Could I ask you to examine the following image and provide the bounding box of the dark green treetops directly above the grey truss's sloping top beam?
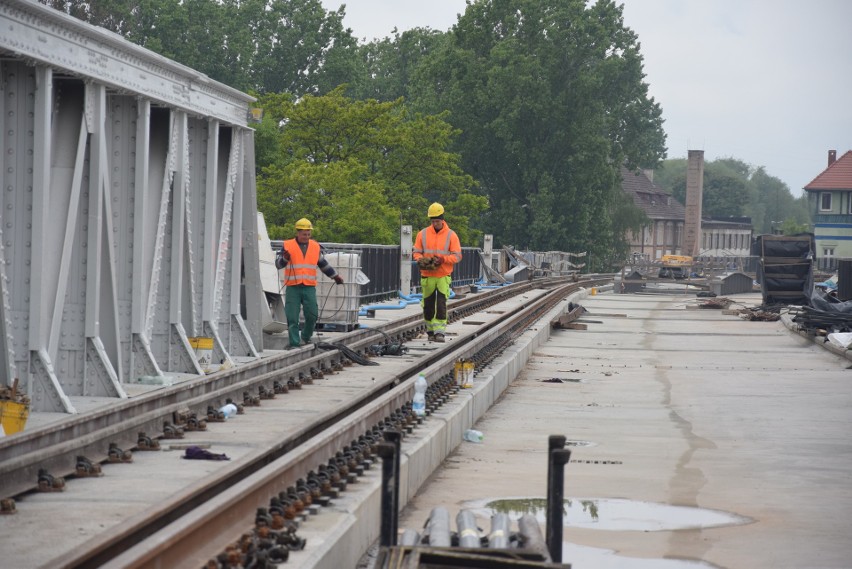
[42,0,366,95]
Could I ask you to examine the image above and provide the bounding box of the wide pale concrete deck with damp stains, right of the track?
[400,294,852,569]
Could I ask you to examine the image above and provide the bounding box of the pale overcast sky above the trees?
[322,0,852,196]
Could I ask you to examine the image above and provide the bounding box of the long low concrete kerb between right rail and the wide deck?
[290,287,588,569]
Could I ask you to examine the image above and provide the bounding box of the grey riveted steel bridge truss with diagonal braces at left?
[0,0,263,413]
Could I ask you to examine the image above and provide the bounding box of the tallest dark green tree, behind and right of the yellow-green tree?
[411,0,665,266]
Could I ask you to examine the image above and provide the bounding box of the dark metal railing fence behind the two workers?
[272,241,482,304]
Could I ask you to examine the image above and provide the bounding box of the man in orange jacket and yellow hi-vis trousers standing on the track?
[414,202,461,342]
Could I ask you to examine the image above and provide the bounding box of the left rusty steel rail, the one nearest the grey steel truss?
[0,278,596,498]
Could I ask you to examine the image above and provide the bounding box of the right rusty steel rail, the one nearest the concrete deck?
[71,280,605,568]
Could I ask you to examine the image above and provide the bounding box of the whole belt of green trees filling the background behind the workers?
[40,0,809,262]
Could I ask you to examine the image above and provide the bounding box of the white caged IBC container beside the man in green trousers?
[317,252,361,331]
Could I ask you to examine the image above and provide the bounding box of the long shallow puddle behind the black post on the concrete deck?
[463,497,751,531]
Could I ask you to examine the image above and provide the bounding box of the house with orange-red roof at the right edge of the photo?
[804,146,852,265]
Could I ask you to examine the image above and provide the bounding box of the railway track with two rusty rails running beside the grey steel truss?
[0,276,610,567]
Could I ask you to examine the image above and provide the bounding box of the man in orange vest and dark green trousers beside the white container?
[275,217,343,347]
